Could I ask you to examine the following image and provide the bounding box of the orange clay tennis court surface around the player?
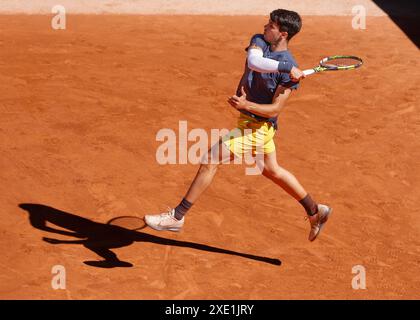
[0,15,420,299]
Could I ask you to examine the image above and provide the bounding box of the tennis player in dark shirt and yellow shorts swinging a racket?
[145,9,332,241]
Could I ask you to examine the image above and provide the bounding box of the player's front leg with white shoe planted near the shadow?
[145,139,234,231]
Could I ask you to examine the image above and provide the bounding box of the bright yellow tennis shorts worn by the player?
[222,113,276,157]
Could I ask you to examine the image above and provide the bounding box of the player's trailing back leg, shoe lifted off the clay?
[262,152,332,241]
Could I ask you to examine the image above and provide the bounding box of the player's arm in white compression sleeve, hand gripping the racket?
[247,44,305,81]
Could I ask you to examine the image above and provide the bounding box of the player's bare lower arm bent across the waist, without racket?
[228,86,292,118]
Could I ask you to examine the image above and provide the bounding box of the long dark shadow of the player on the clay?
[19,203,281,268]
